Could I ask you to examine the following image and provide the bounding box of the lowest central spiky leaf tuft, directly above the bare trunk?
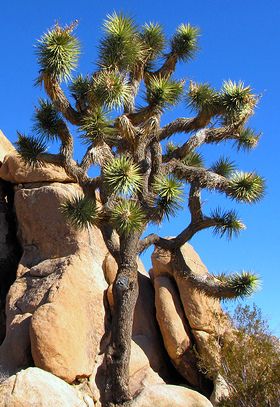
[111,199,145,234]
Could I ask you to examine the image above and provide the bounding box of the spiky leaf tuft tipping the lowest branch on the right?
[215,271,261,298]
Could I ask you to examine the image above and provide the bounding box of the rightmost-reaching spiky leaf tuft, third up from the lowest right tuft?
[228,171,265,203]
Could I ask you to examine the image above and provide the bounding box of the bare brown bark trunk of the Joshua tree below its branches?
[105,233,139,407]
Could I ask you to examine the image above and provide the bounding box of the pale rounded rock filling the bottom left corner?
[0,368,94,407]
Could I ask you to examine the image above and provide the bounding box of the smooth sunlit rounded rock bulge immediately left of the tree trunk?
[30,254,106,383]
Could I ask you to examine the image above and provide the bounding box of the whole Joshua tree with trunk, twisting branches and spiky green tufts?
[17,14,264,405]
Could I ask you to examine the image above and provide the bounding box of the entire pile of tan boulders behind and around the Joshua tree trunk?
[0,133,230,407]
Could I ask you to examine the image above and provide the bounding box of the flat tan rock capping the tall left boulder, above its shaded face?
[0,152,73,184]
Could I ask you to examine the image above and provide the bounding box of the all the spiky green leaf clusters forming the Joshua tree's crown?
[17,13,264,293]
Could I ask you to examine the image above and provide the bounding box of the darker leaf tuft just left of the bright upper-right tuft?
[187,82,220,115]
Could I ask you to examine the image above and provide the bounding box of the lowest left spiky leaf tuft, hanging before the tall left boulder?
[60,195,100,229]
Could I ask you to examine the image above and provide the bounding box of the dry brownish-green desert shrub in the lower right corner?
[200,305,280,407]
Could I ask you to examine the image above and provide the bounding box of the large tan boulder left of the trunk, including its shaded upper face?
[0,183,107,383]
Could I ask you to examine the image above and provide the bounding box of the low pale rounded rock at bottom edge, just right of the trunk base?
[131,384,212,407]
